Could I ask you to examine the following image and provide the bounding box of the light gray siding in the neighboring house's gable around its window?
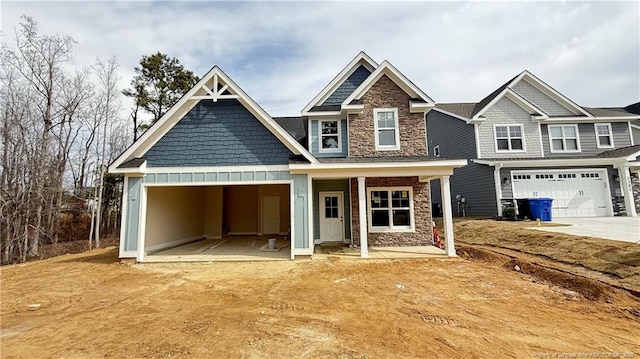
[477,98,542,158]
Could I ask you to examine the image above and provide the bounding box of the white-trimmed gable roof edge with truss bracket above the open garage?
[109,66,317,172]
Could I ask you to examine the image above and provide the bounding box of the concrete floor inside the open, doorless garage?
[144,236,291,263]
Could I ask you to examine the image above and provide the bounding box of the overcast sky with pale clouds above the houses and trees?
[0,1,640,116]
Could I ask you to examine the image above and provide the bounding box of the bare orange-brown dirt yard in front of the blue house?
[0,224,640,358]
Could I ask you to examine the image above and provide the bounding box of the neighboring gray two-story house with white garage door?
[426,71,640,217]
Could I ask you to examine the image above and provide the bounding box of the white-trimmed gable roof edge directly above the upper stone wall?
[342,60,435,106]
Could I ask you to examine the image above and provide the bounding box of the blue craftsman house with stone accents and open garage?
[109,53,467,262]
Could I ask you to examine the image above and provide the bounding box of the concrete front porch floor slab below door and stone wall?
[312,246,448,259]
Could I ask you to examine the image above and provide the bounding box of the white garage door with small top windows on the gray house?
[511,169,612,217]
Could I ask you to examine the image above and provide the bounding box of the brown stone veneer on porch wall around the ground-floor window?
[351,177,433,247]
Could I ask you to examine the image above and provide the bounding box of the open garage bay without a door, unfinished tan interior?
[144,184,291,262]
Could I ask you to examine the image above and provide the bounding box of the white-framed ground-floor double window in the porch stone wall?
[367,187,415,232]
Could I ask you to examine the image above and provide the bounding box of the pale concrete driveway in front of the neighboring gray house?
[529,217,640,244]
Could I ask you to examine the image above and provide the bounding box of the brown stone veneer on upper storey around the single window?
[349,75,427,157]
